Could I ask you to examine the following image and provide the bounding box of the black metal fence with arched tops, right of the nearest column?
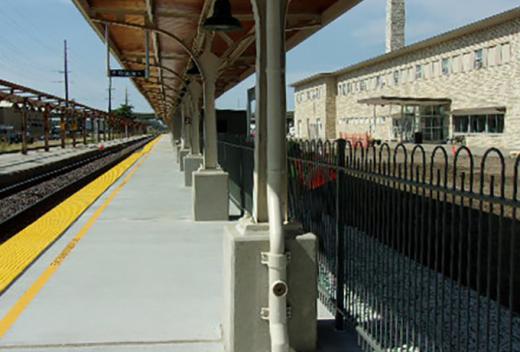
[217,135,520,351]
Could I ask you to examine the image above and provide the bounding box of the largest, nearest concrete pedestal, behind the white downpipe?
[222,220,317,352]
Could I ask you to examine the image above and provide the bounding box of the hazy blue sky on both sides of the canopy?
[0,0,520,111]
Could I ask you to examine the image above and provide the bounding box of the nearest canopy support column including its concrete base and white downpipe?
[222,0,318,352]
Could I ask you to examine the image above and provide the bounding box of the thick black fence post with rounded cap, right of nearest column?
[335,139,347,330]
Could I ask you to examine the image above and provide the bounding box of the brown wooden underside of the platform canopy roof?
[73,0,361,117]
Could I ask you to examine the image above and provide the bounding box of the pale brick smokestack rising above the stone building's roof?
[386,0,406,53]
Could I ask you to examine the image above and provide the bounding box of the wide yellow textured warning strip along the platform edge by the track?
[0,139,158,293]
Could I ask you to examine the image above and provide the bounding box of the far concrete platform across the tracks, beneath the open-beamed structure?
[0,136,142,176]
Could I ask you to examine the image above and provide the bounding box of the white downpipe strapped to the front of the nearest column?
[266,0,289,352]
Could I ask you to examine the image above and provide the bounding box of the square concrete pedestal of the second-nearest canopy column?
[193,170,229,221]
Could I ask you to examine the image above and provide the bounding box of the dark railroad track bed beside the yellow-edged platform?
[0,137,152,244]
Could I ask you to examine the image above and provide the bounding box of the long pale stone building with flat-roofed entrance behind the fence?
[293,5,520,147]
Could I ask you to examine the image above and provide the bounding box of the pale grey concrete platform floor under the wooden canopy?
[0,137,228,352]
